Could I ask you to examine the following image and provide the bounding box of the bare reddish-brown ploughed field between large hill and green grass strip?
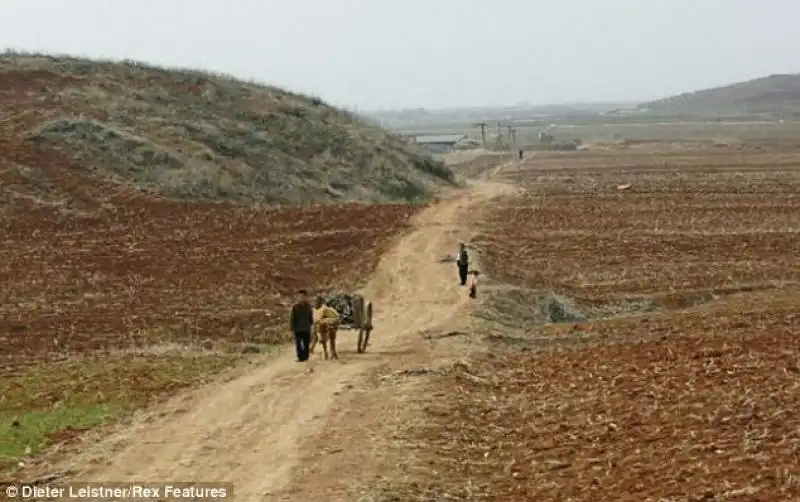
[0,192,417,370]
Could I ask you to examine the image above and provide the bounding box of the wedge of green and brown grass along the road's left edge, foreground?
[0,354,240,473]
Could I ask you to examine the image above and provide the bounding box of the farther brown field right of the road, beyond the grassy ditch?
[478,150,800,301]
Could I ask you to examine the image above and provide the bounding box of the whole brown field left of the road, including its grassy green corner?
[0,140,423,471]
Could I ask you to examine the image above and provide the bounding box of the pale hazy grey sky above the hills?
[0,0,800,110]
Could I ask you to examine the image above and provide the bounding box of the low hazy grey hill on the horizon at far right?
[638,75,800,116]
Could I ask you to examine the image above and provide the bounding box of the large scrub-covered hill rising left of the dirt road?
[0,53,454,204]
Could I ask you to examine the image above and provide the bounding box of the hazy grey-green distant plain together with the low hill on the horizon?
[383,70,800,144]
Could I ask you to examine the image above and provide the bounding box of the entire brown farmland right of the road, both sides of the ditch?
[379,145,800,502]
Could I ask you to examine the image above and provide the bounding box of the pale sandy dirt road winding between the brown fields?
[59,178,509,500]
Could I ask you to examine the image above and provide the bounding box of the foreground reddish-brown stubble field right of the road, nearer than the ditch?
[390,295,800,502]
